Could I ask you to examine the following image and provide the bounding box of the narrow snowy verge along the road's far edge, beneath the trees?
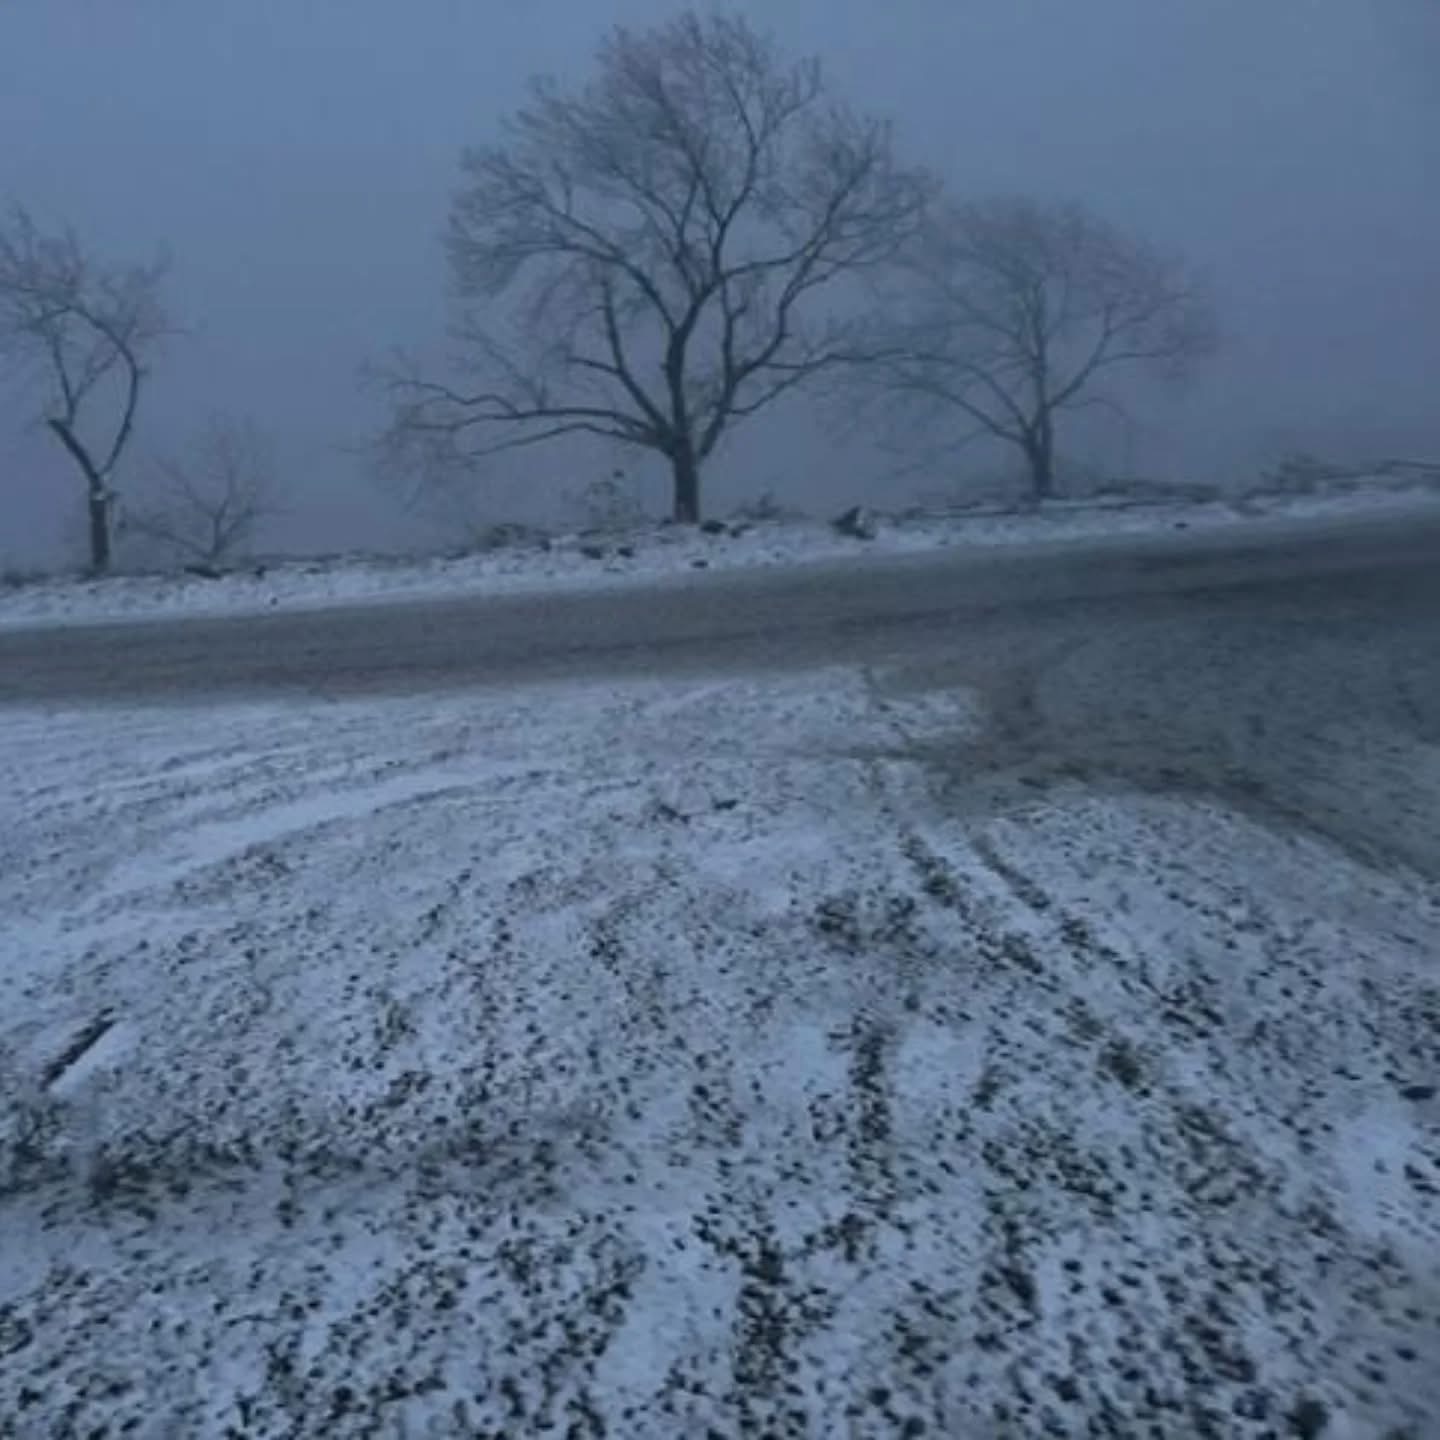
[0,480,1440,626]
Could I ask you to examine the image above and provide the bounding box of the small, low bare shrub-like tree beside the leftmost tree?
[124,416,278,570]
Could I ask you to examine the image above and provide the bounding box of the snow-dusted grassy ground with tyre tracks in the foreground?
[0,671,1440,1440]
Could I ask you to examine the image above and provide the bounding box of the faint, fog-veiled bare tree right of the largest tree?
[874,199,1215,500]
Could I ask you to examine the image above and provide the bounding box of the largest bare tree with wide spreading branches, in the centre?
[389,14,930,521]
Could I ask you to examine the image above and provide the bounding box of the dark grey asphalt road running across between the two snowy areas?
[0,509,1440,704]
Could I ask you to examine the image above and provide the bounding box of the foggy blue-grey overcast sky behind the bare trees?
[0,0,1440,564]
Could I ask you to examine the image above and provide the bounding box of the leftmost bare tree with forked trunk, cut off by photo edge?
[0,209,168,572]
